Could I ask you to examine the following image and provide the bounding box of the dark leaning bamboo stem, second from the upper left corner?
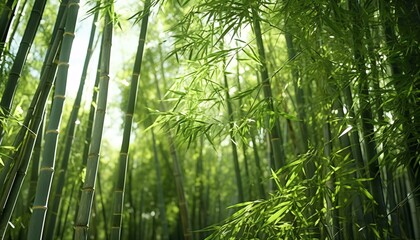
[0,0,46,144]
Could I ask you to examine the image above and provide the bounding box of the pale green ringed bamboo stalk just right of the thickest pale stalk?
[74,1,113,239]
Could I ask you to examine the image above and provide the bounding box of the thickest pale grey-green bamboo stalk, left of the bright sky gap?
[28,0,79,239]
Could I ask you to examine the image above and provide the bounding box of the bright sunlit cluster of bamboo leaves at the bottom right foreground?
[206,150,376,239]
